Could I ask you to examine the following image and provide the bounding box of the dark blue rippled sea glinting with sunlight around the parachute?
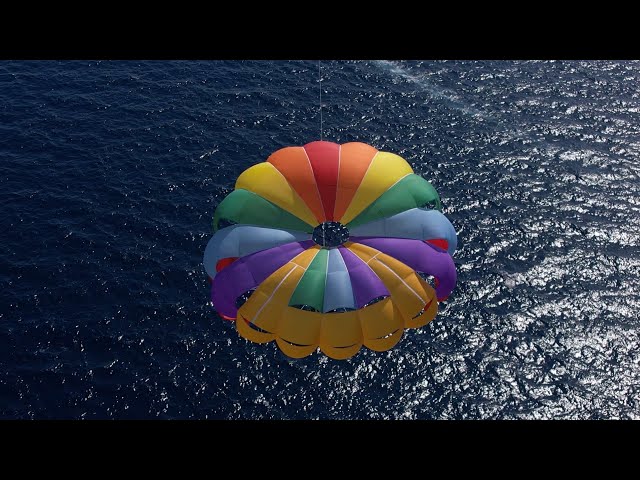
[0,61,640,419]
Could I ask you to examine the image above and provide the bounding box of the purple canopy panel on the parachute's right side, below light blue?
[351,237,457,301]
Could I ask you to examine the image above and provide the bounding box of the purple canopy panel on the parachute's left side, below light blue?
[211,240,313,318]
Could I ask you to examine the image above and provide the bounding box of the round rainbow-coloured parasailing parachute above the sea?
[204,141,457,359]
